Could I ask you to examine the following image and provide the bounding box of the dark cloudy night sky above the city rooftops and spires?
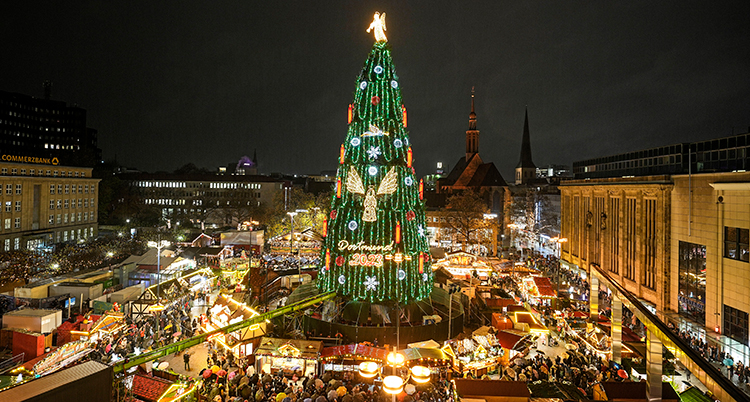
[0,0,750,180]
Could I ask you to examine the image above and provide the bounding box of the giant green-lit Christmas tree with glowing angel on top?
[318,13,433,303]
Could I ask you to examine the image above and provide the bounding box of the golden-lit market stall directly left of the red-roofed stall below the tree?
[255,337,323,376]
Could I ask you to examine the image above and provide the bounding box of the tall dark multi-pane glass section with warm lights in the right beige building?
[678,241,706,325]
